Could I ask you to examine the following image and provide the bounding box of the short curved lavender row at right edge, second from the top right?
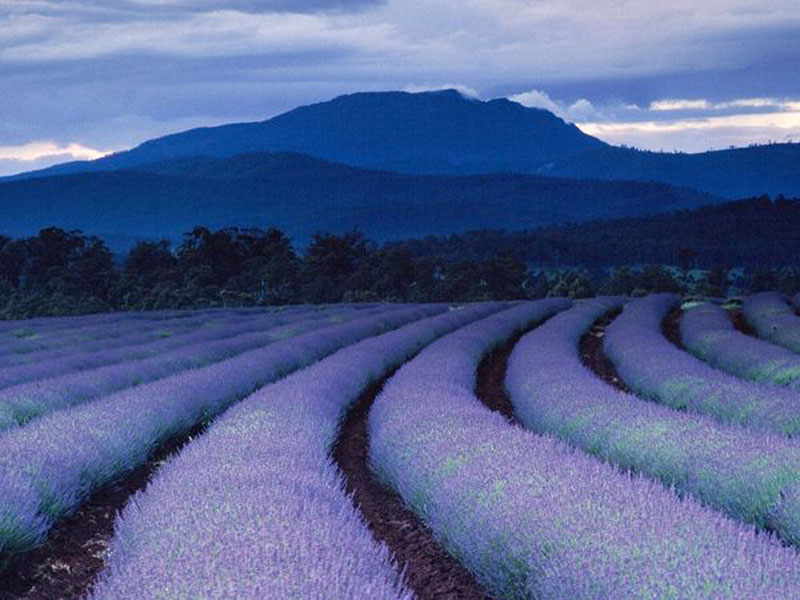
[681,304,800,390]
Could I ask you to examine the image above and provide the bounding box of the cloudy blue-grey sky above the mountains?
[0,0,800,175]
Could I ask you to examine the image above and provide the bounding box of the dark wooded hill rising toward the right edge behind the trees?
[392,197,800,268]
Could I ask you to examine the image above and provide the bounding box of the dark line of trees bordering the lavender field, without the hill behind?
[0,211,800,319]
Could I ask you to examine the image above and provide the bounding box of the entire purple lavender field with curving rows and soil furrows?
[0,292,800,600]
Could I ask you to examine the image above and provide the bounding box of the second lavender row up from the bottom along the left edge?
[0,309,380,428]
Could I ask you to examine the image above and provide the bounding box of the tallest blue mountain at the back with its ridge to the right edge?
[12,90,800,198]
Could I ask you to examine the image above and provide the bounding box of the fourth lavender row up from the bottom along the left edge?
[0,307,315,368]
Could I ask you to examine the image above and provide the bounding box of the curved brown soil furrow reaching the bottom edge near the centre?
[333,377,492,600]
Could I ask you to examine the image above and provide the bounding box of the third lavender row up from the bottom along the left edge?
[0,308,362,389]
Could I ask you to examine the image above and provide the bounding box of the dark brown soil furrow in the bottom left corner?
[0,426,204,600]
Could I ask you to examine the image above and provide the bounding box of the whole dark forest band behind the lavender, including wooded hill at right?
[0,197,800,319]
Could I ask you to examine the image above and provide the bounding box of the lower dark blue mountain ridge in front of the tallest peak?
[0,153,718,248]
